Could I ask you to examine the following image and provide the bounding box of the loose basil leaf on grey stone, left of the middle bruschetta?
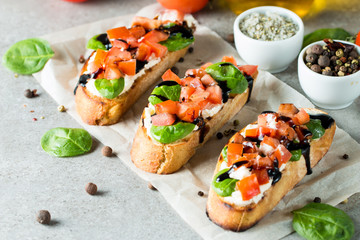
[41,127,92,157]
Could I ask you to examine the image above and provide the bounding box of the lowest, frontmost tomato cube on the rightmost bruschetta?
[236,174,261,201]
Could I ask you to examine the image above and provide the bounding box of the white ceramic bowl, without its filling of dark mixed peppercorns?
[298,40,360,109]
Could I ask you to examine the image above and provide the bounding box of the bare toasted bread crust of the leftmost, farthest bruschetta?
[75,47,188,125]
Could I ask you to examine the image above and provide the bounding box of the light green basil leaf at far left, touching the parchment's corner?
[2,38,54,74]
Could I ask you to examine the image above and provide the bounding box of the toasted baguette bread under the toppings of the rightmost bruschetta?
[206,109,336,231]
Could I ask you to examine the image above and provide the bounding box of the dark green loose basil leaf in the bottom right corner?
[292,203,354,240]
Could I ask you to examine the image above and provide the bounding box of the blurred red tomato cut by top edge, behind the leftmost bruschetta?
[157,0,209,13]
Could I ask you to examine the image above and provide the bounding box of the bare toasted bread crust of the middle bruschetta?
[131,72,257,174]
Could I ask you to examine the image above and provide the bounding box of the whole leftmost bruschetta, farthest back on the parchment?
[74,10,195,125]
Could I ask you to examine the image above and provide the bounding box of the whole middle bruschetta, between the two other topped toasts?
[131,57,258,174]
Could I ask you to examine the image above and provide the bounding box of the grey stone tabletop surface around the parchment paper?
[0,0,360,239]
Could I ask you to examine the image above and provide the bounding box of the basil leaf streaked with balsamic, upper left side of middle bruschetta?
[148,84,181,105]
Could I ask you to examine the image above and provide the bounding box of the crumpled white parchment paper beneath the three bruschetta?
[34,5,360,240]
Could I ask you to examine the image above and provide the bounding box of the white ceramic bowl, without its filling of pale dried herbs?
[234,6,304,73]
